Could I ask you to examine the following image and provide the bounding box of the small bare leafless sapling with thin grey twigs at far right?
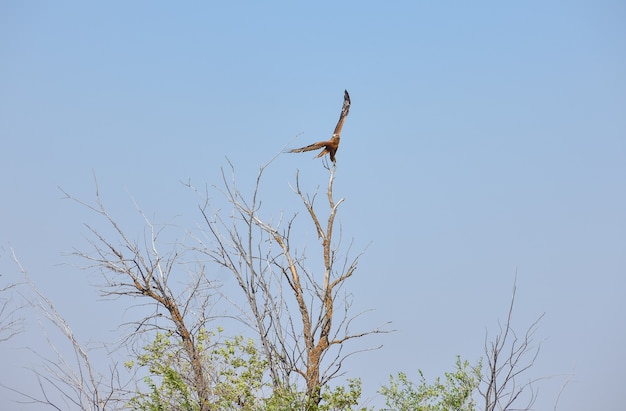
[479,283,544,411]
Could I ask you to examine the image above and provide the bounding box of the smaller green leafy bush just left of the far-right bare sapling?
[379,357,480,411]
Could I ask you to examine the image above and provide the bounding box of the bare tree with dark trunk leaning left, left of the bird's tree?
[59,183,215,411]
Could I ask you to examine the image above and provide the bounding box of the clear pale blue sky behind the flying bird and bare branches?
[0,0,626,411]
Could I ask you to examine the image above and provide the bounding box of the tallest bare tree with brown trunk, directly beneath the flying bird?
[199,159,386,406]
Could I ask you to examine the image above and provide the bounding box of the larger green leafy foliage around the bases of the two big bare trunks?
[125,330,365,411]
